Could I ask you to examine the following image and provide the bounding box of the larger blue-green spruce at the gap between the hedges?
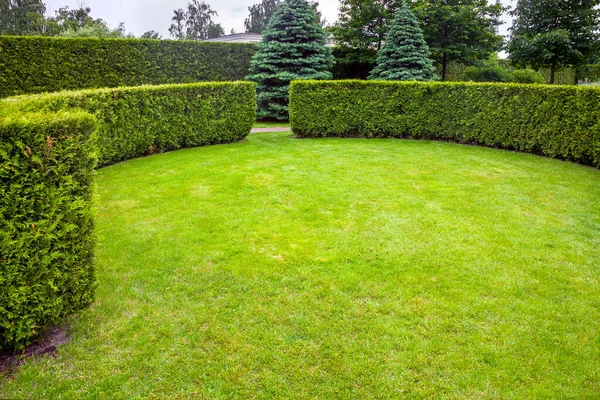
[246,0,333,120]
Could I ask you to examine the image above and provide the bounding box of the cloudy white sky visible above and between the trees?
[44,0,511,39]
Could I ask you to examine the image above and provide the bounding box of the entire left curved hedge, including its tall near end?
[0,82,256,350]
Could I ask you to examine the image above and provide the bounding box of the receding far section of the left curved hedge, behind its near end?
[7,82,256,166]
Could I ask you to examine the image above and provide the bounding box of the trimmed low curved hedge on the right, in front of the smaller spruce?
[290,81,600,167]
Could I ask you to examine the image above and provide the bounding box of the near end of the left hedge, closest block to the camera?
[0,111,96,350]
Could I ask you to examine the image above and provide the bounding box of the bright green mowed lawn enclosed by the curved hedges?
[0,132,600,399]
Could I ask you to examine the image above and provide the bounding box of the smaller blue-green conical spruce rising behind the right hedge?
[369,3,437,81]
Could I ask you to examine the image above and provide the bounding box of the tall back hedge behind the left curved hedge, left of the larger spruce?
[0,36,256,97]
